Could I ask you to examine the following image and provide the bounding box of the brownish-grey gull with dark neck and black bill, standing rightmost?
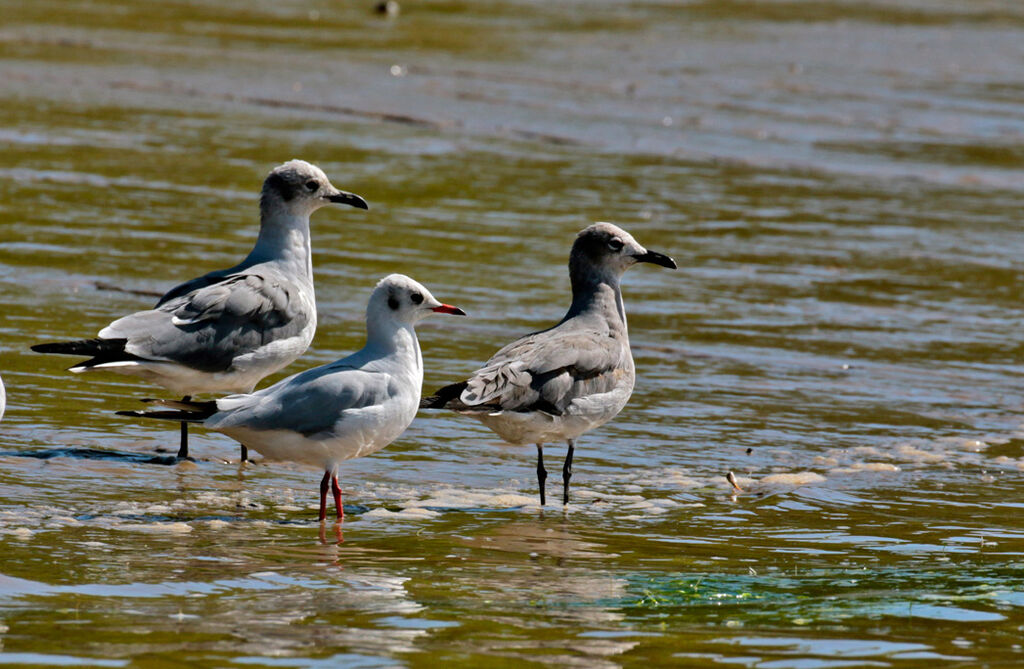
[421,223,676,505]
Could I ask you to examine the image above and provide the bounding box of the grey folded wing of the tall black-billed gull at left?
[99,267,315,372]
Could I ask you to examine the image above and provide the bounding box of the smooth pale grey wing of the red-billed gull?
[207,363,396,437]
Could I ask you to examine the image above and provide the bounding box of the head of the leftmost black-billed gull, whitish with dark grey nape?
[260,160,370,216]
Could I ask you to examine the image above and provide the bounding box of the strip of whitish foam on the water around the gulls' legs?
[0,434,1024,536]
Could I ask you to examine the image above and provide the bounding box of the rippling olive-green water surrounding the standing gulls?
[0,0,1024,669]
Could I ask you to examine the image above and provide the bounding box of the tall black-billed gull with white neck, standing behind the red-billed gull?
[32,160,368,460]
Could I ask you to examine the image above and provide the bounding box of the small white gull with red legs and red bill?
[118,275,465,520]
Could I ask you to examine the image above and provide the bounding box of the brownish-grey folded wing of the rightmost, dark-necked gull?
[460,327,633,415]
